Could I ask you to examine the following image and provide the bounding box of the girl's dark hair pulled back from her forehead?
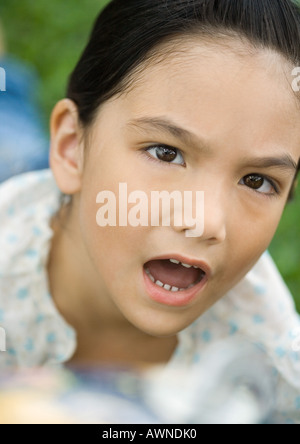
[67,0,300,195]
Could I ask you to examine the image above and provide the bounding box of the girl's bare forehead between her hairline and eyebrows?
[102,39,300,159]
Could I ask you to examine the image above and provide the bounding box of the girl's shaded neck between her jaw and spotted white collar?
[47,203,177,365]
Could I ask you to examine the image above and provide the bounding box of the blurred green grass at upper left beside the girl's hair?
[0,0,110,120]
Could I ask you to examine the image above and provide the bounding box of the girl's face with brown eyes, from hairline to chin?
[52,41,300,336]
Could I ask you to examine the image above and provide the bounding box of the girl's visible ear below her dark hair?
[50,99,84,194]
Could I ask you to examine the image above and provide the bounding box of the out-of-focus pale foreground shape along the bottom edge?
[0,340,292,424]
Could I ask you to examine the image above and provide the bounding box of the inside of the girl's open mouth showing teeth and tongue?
[144,258,207,293]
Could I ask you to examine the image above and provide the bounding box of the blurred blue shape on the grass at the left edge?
[0,23,49,182]
